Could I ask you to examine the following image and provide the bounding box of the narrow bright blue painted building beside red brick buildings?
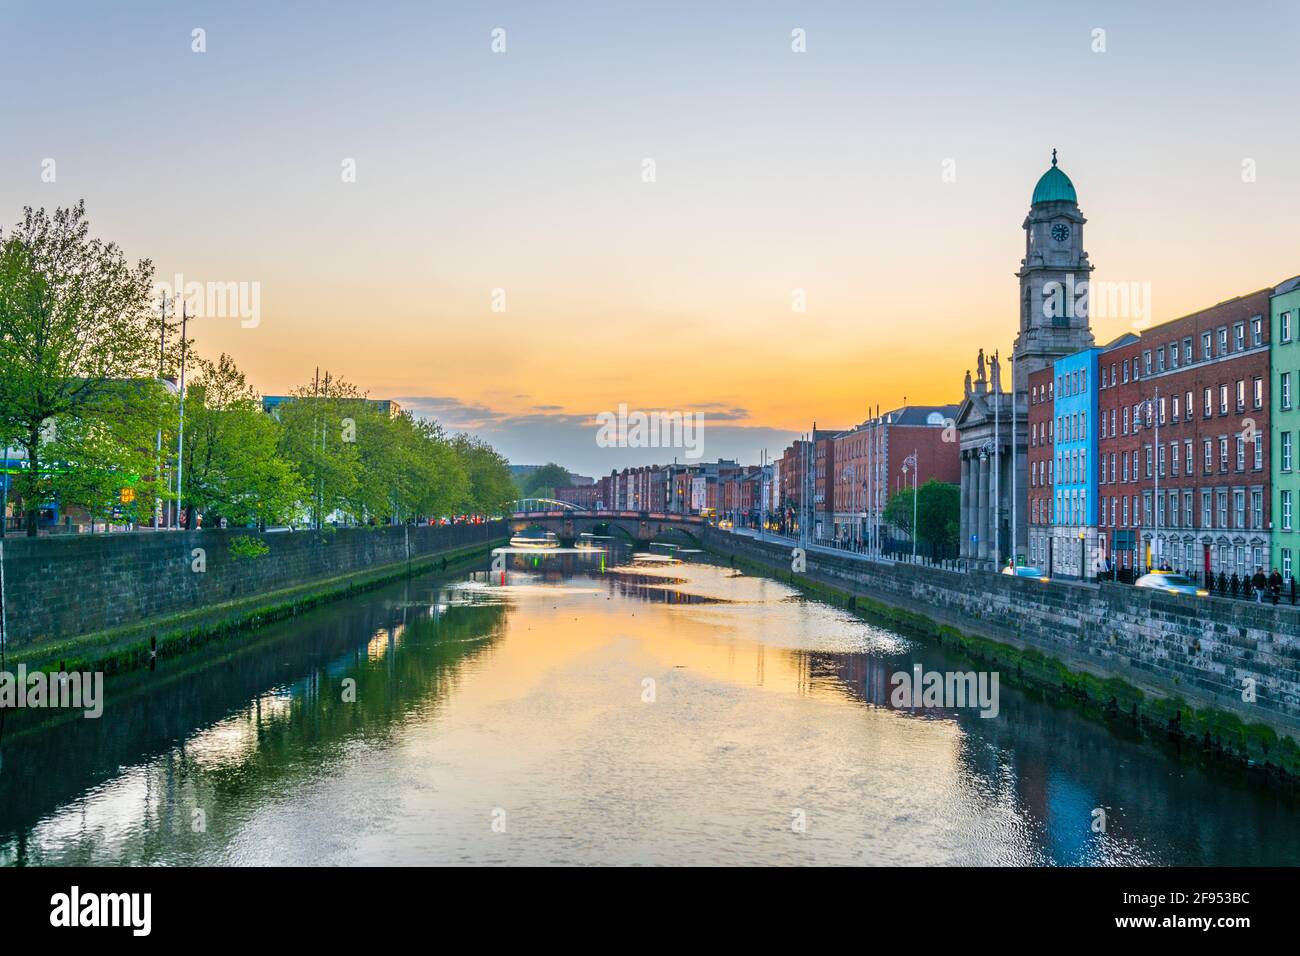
[1050,349,1101,578]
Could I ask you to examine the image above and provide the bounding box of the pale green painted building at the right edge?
[1269,276,1300,579]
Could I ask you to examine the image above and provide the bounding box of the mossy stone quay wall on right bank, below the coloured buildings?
[703,528,1300,739]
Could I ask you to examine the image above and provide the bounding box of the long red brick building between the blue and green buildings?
[1097,289,1271,576]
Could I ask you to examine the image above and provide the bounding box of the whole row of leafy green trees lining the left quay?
[0,204,527,535]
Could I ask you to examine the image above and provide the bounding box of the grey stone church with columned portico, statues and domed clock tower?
[957,150,1093,570]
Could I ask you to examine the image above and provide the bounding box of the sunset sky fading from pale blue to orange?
[0,0,1300,475]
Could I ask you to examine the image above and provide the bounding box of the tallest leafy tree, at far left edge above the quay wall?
[0,202,155,535]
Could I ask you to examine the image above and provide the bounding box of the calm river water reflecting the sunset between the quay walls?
[0,548,1300,865]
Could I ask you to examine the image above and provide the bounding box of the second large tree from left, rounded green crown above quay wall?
[183,352,307,528]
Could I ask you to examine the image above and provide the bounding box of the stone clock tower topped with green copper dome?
[1011,150,1093,393]
